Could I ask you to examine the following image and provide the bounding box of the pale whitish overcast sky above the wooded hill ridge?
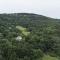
[0,0,60,19]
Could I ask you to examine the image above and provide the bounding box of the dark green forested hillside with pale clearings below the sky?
[0,13,60,60]
